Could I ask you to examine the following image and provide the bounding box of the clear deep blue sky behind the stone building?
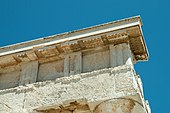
[0,0,170,113]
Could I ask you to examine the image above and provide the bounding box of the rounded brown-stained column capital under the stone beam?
[94,98,146,113]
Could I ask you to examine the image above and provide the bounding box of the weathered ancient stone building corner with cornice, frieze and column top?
[0,16,151,113]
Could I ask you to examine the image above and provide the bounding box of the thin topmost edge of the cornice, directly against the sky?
[0,15,142,56]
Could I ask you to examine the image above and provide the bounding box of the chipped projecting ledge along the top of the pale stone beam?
[0,65,134,95]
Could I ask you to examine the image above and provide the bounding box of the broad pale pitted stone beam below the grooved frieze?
[0,65,145,113]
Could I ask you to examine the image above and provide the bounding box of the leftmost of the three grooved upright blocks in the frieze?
[19,61,39,85]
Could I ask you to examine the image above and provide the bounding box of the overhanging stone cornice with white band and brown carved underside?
[0,16,148,67]
